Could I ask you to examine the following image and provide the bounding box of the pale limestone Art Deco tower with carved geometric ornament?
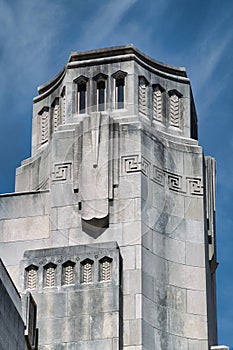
[0,45,217,350]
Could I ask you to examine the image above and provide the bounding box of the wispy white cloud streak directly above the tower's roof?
[79,0,137,47]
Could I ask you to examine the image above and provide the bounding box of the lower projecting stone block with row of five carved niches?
[21,243,122,350]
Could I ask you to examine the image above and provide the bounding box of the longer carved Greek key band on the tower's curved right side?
[121,155,203,196]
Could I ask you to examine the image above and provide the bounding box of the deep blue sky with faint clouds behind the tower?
[0,0,233,347]
